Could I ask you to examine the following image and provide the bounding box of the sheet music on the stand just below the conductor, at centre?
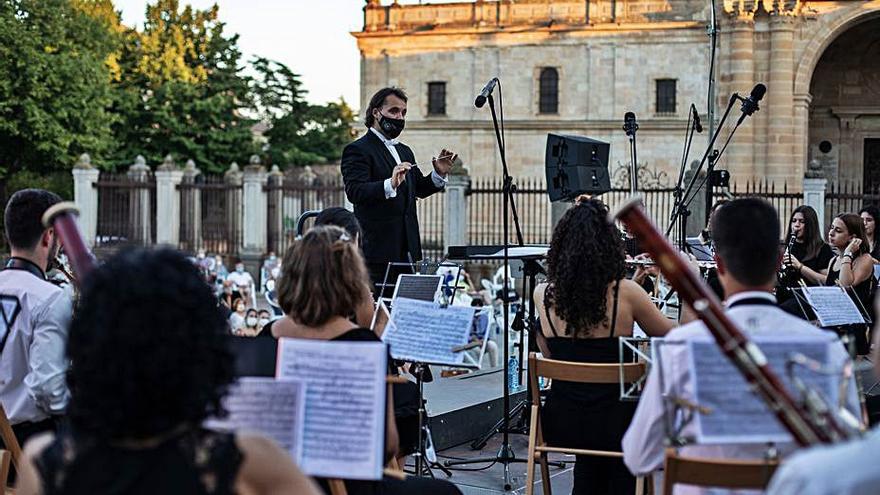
[382,298,474,366]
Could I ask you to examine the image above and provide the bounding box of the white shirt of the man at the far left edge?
[0,269,72,425]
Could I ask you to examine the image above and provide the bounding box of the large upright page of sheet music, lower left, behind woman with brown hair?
[277,338,388,480]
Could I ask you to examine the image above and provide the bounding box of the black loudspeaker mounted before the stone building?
[544,134,611,201]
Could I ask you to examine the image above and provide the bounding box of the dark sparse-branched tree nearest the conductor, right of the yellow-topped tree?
[251,57,356,168]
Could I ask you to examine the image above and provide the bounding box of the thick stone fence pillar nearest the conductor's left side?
[241,155,268,283]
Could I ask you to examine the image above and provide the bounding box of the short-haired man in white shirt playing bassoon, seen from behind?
[623,198,859,494]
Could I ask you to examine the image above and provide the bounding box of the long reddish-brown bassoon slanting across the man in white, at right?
[614,198,851,446]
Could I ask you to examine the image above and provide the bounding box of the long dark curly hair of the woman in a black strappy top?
[546,199,626,336]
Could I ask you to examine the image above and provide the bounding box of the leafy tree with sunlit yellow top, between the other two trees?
[107,0,256,172]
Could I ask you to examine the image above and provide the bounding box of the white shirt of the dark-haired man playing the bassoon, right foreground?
[623,292,860,495]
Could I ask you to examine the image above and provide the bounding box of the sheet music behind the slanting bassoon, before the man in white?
[688,336,839,444]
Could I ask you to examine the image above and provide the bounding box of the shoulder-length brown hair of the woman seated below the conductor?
[278,225,369,327]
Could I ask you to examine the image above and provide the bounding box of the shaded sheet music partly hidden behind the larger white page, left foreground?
[205,377,306,463]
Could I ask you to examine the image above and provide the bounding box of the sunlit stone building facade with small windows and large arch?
[353,0,880,190]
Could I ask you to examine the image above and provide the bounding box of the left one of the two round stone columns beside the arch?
[719,19,758,181]
